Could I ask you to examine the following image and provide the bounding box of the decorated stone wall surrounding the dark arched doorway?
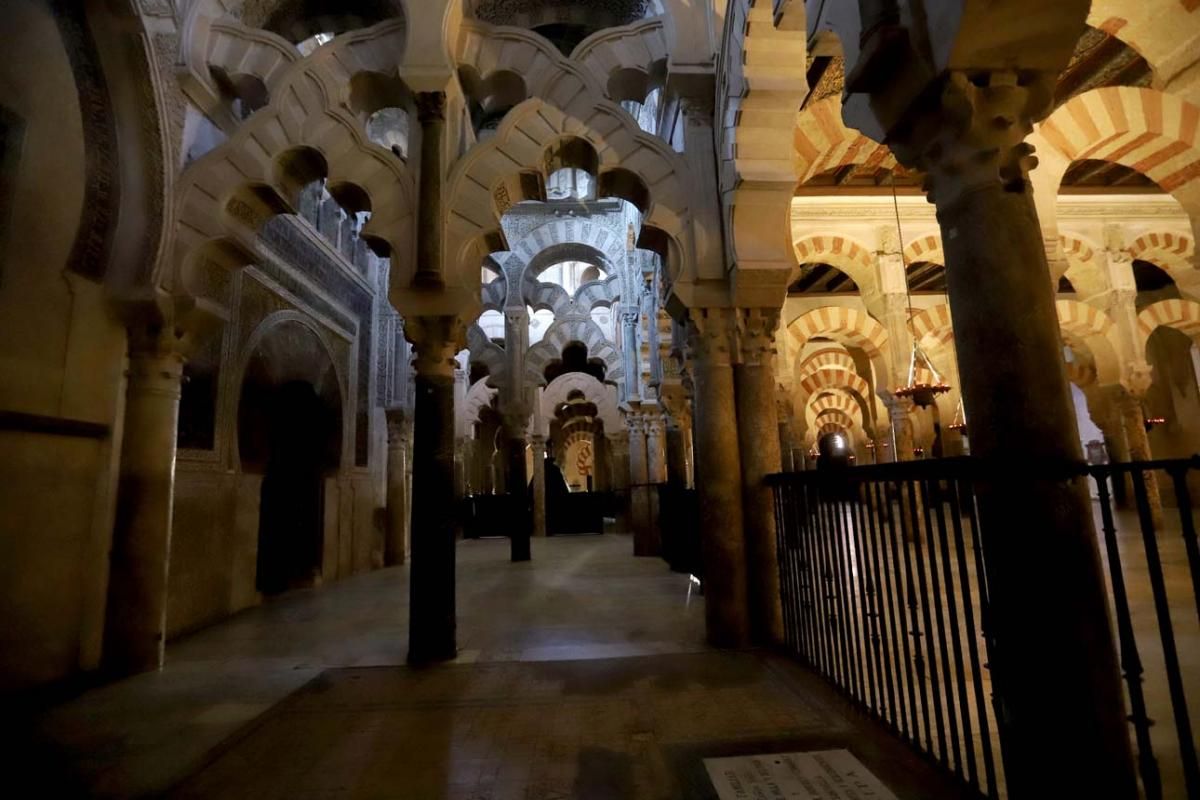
[167,217,386,637]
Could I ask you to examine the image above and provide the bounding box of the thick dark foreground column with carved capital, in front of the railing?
[888,71,1138,798]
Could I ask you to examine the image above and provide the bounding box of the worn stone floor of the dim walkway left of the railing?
[16,536,974,800]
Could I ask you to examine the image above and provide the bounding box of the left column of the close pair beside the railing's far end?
[688,308,750,648]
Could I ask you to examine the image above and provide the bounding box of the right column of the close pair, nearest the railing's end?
[733,308,784,645]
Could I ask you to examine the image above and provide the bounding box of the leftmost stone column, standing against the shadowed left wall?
[103,323,184,676]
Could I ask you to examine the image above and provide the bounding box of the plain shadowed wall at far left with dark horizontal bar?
[0,0,125,690]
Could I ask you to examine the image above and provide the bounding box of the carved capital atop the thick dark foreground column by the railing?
[888,70,1055,207]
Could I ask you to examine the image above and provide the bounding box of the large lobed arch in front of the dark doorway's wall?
[169,31,420,315]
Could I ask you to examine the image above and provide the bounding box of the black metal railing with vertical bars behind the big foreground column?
[768,458,1200,800]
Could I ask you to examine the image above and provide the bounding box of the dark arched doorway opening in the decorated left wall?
[238,320,342,595]
